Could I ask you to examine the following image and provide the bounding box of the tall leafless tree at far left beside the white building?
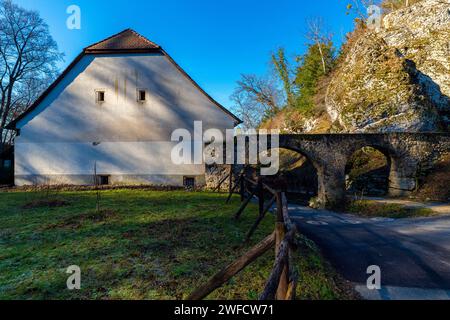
[0,0,63,142]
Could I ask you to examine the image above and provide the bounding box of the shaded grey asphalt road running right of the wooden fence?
[290,205,450,300]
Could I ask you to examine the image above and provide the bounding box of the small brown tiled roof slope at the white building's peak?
[84,29,160,53]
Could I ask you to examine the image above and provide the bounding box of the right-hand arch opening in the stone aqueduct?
[345,146,392,197]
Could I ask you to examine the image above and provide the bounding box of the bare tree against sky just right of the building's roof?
[231,75,284,128]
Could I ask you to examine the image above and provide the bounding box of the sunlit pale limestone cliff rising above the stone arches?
[325,0,450,132]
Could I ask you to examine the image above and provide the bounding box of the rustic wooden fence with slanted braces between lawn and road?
[188,168,298,300]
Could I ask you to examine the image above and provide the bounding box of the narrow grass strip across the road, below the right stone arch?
[347,200,436,219]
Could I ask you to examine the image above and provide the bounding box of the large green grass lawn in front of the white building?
[0,189,352,299]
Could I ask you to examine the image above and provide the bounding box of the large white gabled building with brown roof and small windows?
[9,29,239,186]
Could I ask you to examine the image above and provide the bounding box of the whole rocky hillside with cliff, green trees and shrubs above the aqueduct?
[241,0,450,133]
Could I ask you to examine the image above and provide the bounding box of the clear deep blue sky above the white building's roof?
[13,0,353,108]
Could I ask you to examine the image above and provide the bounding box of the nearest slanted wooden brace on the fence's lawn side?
[188,233,275,300]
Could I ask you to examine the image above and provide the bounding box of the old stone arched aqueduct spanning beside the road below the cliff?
[230,133,450,207]
